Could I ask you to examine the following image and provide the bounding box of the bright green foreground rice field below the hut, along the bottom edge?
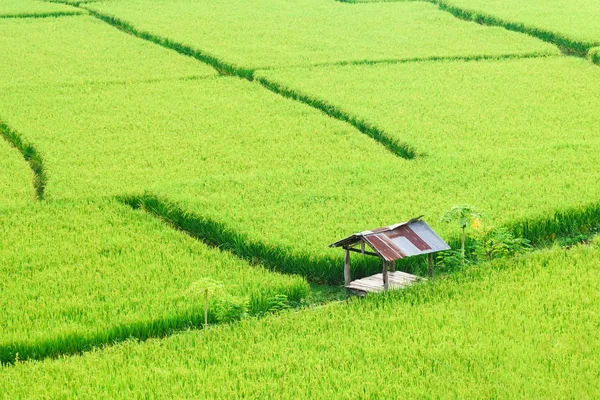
[0,244,600,399]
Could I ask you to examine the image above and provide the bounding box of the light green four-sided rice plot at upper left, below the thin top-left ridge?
[0,16,216,91]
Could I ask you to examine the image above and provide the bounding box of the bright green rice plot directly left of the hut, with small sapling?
[0,201,308,363]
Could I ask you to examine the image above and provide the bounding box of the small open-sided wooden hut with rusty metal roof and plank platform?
[329,217,450,294]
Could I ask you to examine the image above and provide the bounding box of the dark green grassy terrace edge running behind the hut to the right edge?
[119,193,600,286]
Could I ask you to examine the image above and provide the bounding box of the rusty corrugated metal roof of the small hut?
[329,217,450,261]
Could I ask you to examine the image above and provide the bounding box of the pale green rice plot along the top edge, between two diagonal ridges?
[83,0,558,70]
